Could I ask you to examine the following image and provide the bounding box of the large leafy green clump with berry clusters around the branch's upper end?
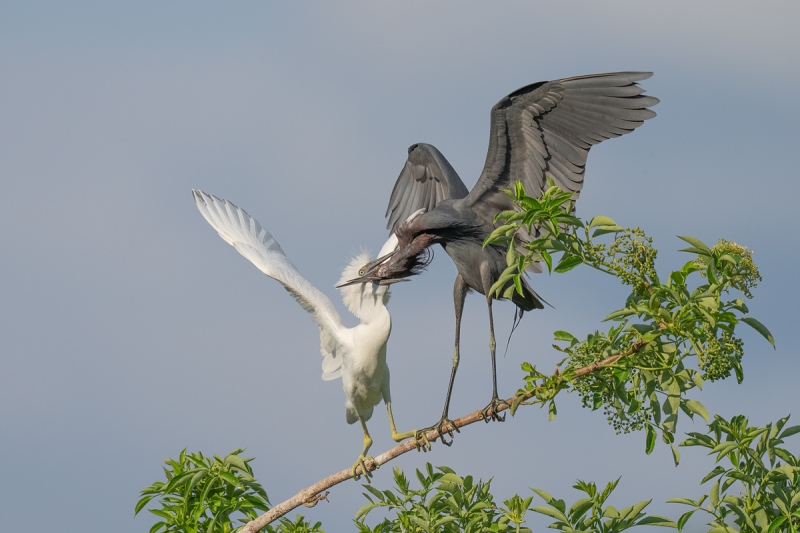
[484,183,774,464]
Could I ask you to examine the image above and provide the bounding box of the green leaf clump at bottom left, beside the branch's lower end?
[135,449,322,533]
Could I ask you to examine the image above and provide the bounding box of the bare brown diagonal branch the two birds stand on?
[240,339,647,533]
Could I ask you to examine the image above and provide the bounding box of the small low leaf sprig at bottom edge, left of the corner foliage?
[531,479,676,533]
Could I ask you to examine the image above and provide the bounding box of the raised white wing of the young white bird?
[192,190,343,380]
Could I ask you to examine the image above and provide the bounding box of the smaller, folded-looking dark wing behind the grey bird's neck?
[386,143,468,233]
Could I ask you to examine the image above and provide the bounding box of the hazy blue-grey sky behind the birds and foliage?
[0,0,800,532]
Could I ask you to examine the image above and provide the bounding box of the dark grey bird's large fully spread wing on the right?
[466,72,659,218]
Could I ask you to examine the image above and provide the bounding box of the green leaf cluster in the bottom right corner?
[669,415,800,533]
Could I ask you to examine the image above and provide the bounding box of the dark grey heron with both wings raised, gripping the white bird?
[340,72,658,445]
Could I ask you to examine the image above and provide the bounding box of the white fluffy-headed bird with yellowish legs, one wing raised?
[192,190,416,480]
